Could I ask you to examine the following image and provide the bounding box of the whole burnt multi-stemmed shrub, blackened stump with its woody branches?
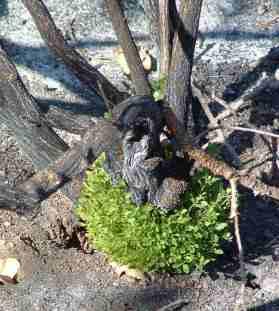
[0,0,252,222]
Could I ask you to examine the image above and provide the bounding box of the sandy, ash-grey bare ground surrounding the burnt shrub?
[0,0,279,311]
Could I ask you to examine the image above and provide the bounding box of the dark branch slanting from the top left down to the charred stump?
[22,0,126,105]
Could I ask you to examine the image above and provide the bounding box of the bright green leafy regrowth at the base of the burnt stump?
[76,156,230,273]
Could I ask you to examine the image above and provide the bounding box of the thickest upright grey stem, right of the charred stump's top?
[167,0,202,144]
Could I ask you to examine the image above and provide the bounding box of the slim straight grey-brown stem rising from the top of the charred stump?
[105,0,152,95]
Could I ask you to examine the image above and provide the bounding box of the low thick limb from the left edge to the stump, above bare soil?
[0,118,120,213]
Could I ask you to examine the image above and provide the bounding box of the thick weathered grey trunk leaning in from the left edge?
[0,43,68,169]
